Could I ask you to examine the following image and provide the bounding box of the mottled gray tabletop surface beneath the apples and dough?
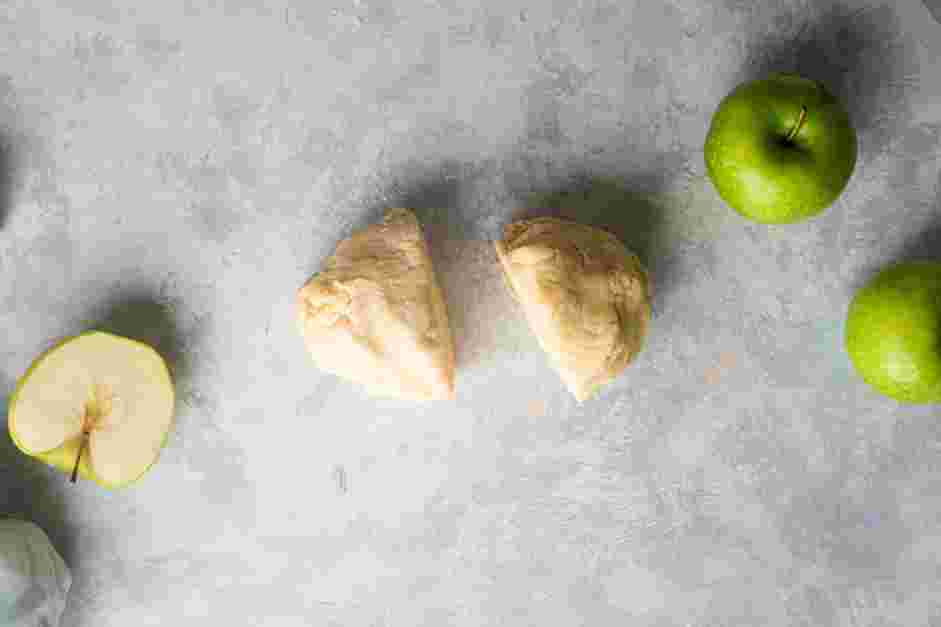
[0,0,941,627]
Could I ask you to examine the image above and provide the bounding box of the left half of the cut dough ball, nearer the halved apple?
[298,209,454,400]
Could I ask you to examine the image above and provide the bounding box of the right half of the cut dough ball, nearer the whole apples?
[496,218,650,401]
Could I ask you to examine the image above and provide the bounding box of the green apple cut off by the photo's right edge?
[846,261,941,403]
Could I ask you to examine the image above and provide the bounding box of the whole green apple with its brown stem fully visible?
[705,74,856,224]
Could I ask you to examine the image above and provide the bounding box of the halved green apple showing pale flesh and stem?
[8,331,174,488]
